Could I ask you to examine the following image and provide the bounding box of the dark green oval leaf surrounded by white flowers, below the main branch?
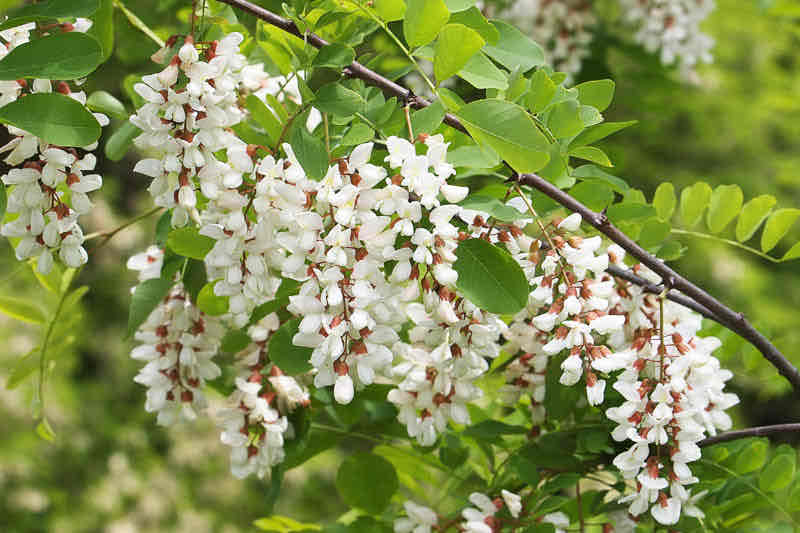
[453,239,530,315]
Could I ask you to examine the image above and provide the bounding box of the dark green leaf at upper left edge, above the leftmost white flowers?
[0,31,103,80]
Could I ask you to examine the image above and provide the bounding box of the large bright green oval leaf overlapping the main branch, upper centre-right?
[457,99,550,173]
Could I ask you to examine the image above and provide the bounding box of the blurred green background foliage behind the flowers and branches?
[0,0,800,533]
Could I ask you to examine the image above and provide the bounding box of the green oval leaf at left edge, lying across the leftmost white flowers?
[0,93,100,147]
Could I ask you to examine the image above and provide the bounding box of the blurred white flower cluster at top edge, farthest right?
[620,0,714,71]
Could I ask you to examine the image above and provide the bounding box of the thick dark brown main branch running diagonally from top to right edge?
[220,0,800,390]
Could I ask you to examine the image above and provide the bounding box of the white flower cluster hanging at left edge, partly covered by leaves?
[0,19,108,274]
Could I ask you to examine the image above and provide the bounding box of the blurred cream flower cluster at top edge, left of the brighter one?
[500,0,596,75]
